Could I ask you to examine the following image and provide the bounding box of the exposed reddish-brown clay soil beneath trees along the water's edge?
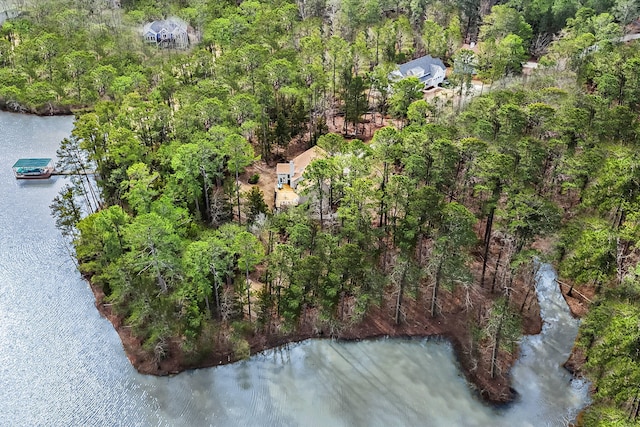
[91,254,542,404]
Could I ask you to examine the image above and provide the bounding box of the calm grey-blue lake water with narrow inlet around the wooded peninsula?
[0,113,588,427]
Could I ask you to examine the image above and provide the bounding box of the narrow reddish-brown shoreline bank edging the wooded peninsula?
[85,272,542,406]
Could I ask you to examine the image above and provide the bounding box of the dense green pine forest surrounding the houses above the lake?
[0,0,640,426]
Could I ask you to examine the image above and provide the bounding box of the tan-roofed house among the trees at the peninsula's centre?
[275,146,326,209]
